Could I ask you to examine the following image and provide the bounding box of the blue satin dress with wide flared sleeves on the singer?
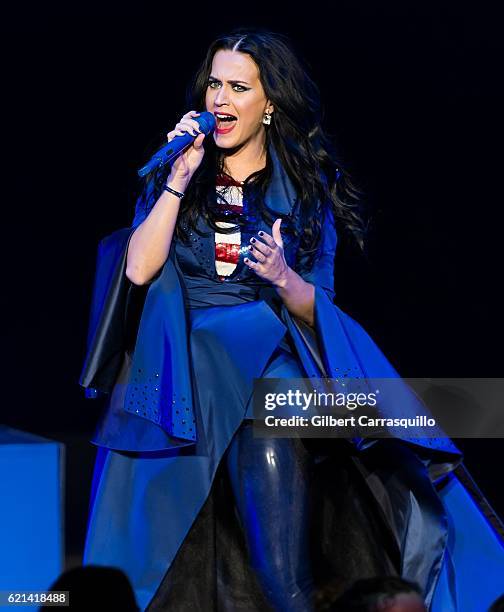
[81,145,504,612]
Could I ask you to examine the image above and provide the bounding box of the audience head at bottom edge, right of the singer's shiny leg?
[329,576,427,612]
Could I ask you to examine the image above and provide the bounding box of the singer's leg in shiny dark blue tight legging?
[226,421,314,612]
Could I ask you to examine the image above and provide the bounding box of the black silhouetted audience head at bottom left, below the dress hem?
[39,565,139,612]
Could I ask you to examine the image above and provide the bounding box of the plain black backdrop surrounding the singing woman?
[0,0,504,551]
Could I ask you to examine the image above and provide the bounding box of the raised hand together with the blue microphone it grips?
[138,111,215,184]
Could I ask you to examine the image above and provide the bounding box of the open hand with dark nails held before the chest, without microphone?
[243,219,289,287]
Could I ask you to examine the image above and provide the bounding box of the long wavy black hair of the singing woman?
[137,28,365,265]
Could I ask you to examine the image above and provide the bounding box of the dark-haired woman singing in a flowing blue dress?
[81,29,504,612]
